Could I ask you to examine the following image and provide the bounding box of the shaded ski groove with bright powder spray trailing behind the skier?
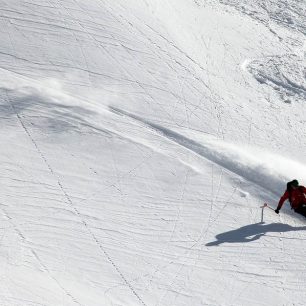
[110,107,306,194]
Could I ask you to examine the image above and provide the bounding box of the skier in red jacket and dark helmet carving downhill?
[275,180,306,217]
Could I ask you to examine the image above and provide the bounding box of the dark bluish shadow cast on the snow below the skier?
[206,222,306,246]
